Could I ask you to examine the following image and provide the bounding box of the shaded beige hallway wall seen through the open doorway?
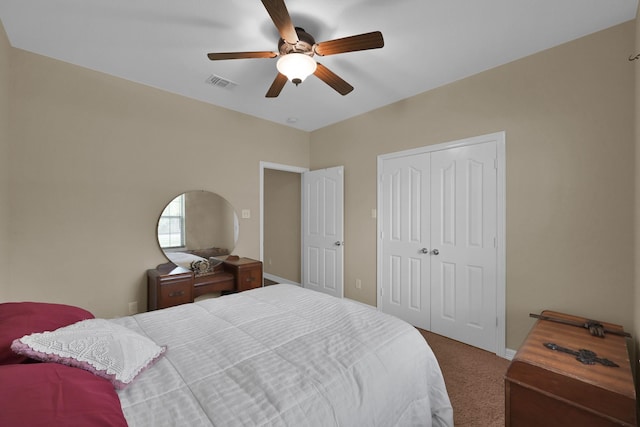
[264,169,302,283]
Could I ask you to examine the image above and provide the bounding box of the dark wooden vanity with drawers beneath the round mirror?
[147,257,262,310]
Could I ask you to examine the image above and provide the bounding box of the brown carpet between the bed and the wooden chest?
[418,329,509,427]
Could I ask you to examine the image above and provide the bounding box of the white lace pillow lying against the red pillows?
[11,319,166,389]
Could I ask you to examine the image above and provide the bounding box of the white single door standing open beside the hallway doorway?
[302,166,344,298]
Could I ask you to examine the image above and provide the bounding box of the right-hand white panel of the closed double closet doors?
[430,142,497,351]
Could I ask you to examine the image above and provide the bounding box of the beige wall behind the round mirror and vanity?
[6,49,309,316]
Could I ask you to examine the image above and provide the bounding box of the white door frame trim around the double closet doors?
[376,131,507,357]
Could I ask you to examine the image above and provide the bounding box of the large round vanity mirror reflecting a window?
[158,191,238,268]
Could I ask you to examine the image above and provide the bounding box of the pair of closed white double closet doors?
[378,134,504,351]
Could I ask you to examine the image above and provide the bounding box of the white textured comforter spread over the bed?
[113,285,453,427]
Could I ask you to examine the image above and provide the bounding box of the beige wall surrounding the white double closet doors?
[311,22,634,349]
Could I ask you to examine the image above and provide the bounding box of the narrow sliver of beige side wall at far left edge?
[0,21,11,301]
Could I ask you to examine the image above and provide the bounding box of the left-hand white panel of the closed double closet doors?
[379,153,431,329]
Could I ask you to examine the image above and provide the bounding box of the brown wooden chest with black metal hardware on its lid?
[505,311,636,427]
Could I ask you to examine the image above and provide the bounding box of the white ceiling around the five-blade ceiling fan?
[0,0,638,131]
